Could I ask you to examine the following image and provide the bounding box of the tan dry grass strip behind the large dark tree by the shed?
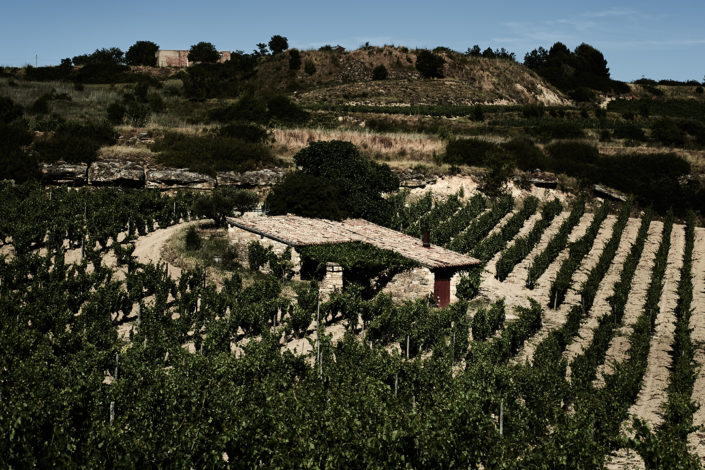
[273,128,445,164]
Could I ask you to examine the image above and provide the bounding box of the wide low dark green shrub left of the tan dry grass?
[151,132,277,176]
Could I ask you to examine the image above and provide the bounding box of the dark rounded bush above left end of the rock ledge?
[34,122,117,163]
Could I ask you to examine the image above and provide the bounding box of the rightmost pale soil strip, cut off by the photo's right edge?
[688,228,705,462]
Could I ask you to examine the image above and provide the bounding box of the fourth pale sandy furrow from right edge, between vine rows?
[564,219,641,376]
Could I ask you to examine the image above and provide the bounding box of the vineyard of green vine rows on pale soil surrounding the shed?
[0,185,705,468]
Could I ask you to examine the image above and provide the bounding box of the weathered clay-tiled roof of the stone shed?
[227,215,480,269]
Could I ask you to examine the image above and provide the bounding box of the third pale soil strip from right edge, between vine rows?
[595,221,663,387]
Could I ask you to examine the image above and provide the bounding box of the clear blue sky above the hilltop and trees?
[0,0,705,81]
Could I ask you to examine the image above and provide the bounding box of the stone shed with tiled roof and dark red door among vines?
[227,215,480,307]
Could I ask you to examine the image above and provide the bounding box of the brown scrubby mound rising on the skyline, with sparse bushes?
[257,46,569,105]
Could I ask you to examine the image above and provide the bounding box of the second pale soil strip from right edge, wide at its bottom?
[624,225,685,429]
